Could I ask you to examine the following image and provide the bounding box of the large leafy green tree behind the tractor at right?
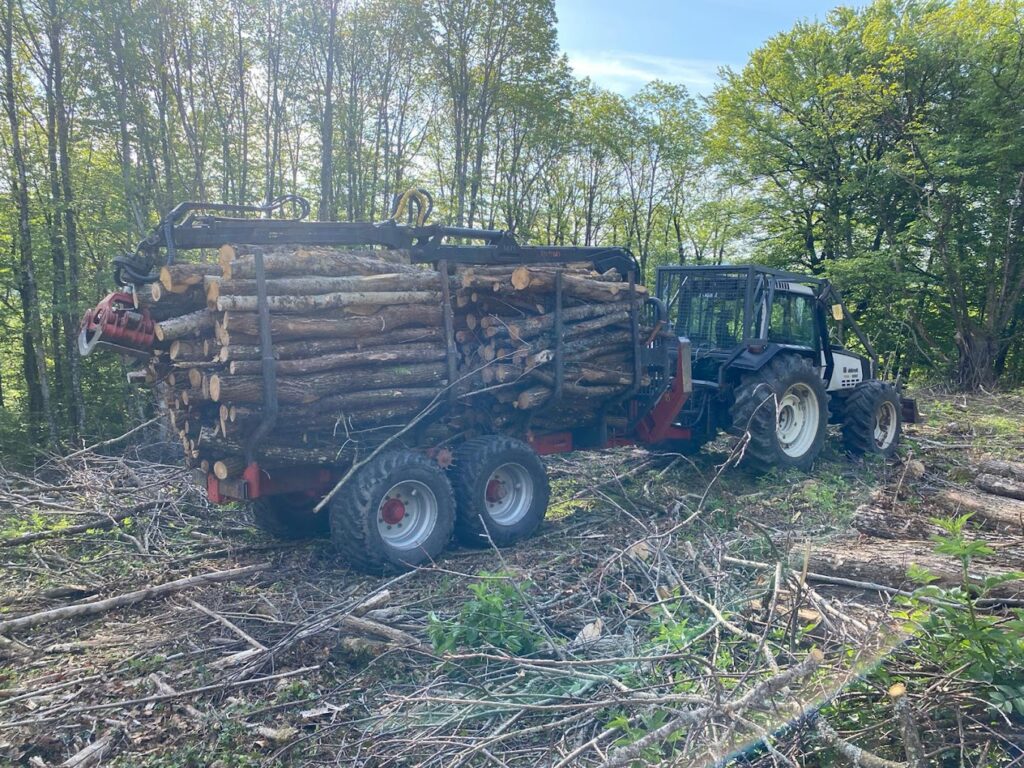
[711,0,1024,387]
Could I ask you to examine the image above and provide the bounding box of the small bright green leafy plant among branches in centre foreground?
[427,571,542,655]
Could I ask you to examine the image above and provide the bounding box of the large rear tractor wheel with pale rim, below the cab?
[732,354,828,472]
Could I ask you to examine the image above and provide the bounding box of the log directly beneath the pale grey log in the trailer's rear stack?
[222,304,441,344]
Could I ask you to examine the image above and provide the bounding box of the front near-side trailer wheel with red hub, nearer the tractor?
[452,435,551,547]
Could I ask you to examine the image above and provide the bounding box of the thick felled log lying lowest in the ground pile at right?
[791,537,1024,599]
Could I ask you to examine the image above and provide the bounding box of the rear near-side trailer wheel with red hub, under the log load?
[331,451,455,573]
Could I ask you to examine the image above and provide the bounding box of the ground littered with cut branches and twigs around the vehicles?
[0,394,1024,768]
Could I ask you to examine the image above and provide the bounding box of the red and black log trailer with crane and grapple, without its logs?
[79,190,691,572]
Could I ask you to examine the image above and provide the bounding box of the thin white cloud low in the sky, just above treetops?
[565,50,723,95]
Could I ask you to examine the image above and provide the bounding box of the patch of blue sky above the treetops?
[555,0,860,94]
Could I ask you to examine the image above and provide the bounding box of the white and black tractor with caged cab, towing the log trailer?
[656,264,915,470]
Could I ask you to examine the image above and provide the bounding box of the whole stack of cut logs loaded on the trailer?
[136,246,650,479]
